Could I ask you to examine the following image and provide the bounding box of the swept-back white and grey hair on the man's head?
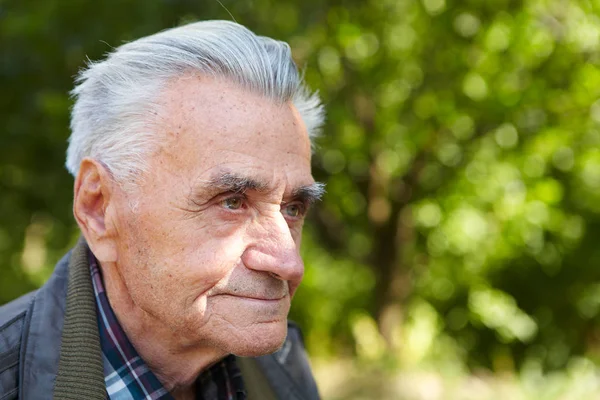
[66,21,324,183]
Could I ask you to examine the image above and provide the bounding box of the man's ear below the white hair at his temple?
[73,157,118,262]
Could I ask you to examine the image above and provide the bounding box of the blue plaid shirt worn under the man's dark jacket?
[89,252,246,400]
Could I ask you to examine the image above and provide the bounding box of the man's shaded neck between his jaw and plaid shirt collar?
[101,263,226,400]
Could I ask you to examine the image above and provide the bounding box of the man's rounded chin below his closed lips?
[230,321,287,357]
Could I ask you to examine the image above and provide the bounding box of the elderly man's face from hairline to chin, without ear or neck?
[107,76,315,356]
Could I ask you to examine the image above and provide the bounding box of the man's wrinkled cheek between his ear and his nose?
[117,203,251,308]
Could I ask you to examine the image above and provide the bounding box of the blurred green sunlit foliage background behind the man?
[0,0,600,400]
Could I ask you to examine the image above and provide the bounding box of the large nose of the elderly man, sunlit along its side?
[242,213,304,294]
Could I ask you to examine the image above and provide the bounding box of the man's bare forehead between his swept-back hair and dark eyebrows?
[147,76,311,190]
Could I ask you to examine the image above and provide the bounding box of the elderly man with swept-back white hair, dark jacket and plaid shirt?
[0,21,323,400]
